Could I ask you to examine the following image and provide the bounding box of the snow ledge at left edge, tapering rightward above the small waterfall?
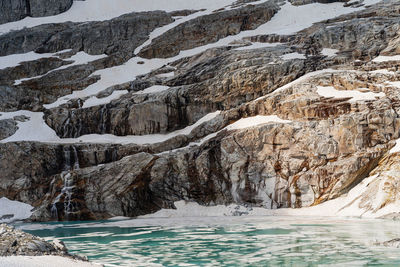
[0,111,220,144]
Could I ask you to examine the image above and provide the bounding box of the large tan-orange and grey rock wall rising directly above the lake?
[28,68,400,220]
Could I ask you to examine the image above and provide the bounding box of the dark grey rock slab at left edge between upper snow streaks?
[0,56,125,112]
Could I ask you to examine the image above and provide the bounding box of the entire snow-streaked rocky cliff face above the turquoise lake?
[0,0,400,221]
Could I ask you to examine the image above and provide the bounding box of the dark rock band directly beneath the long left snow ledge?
[0,114,228,207]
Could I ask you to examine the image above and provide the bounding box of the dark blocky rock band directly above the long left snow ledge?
[46,90,217,138]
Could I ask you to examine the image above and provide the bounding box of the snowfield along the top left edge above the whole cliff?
[0,0,236,34]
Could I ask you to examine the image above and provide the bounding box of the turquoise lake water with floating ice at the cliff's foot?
[19,217,400,266]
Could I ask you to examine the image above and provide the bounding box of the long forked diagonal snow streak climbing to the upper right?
[43,0,372,109]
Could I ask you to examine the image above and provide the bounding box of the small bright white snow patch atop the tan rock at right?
[317,86,386,102]
